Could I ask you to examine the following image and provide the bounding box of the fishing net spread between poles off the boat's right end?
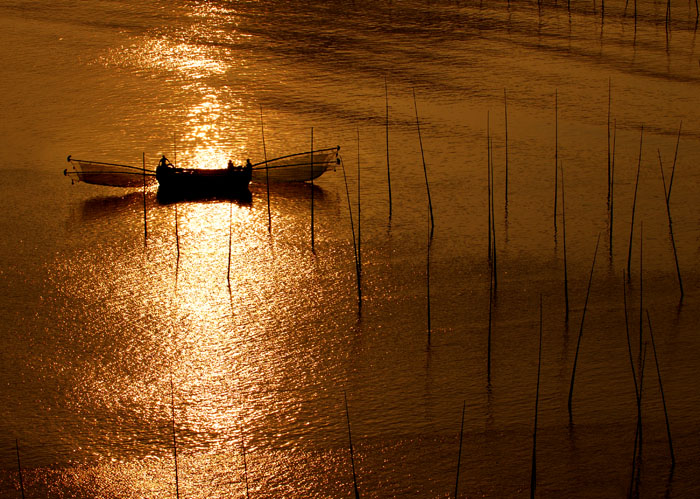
[252,146,340,183]
